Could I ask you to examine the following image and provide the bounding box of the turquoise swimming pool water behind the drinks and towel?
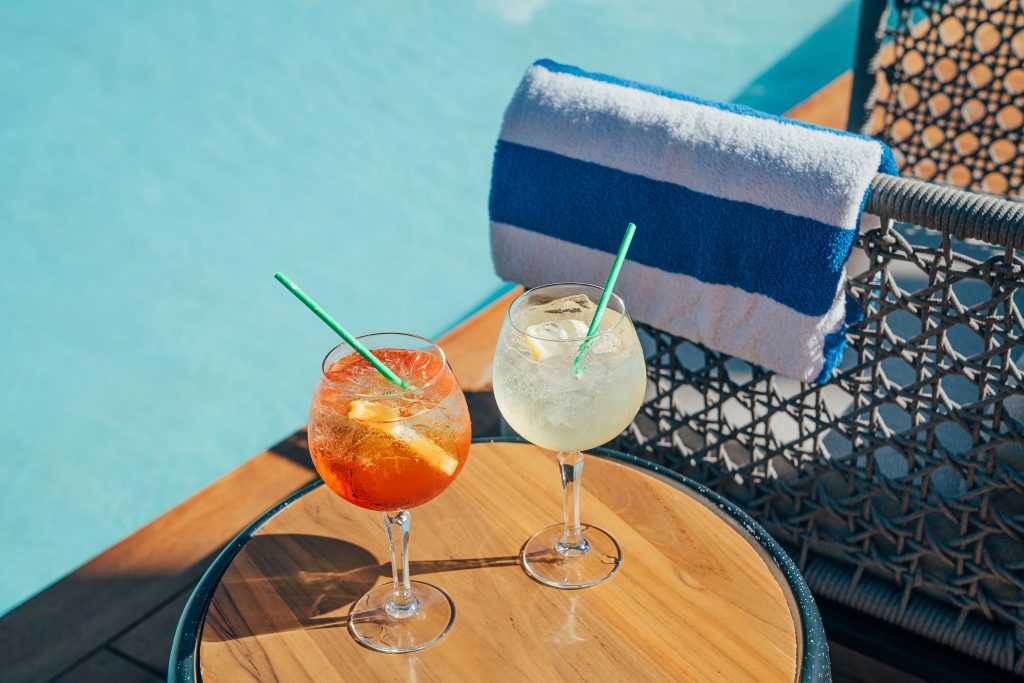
[0,0,856,613]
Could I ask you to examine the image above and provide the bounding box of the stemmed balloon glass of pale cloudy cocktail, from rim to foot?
[494,284,646,589]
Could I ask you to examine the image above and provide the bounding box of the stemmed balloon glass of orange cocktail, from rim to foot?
[308,333,470,652]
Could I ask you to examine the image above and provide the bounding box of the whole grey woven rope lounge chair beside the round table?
[614,0,1024,679]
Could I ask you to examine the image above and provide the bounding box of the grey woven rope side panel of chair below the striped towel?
[615,211,1024,672]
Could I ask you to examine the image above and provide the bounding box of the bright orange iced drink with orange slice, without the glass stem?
[309,348,470,512]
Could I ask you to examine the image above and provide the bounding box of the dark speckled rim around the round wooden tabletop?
[167,436,831,683]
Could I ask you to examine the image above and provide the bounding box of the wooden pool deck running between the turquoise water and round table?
[0,73,920,683]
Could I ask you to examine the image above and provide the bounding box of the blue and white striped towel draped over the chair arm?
[490,59,896,382]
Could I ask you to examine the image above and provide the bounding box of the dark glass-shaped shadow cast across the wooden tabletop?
[203,533,519,642]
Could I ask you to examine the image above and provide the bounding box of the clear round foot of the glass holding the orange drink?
[348,581,455,653]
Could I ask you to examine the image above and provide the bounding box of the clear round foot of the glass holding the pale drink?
[520,524,623,590]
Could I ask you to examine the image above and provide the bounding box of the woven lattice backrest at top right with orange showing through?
[863,0,1024,199]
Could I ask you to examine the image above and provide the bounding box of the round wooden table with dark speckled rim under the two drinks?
[171,440,828,683]
